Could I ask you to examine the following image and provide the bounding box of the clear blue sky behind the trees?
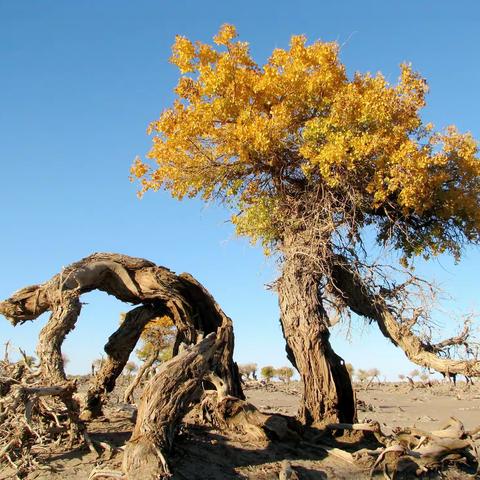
[0,0,480,378]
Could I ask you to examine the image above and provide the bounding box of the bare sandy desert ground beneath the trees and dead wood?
[0,377,480,480]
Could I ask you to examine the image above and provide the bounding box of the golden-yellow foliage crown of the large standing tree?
[131,25,480,257]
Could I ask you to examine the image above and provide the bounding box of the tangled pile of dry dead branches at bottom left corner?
[0,347,85,478]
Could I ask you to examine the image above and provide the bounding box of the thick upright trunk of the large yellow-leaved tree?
[277,246,356,426]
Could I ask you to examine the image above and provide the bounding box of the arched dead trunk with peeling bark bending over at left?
[0,253,243,415]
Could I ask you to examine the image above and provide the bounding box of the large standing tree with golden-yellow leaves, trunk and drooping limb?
[131,25,480,424]
